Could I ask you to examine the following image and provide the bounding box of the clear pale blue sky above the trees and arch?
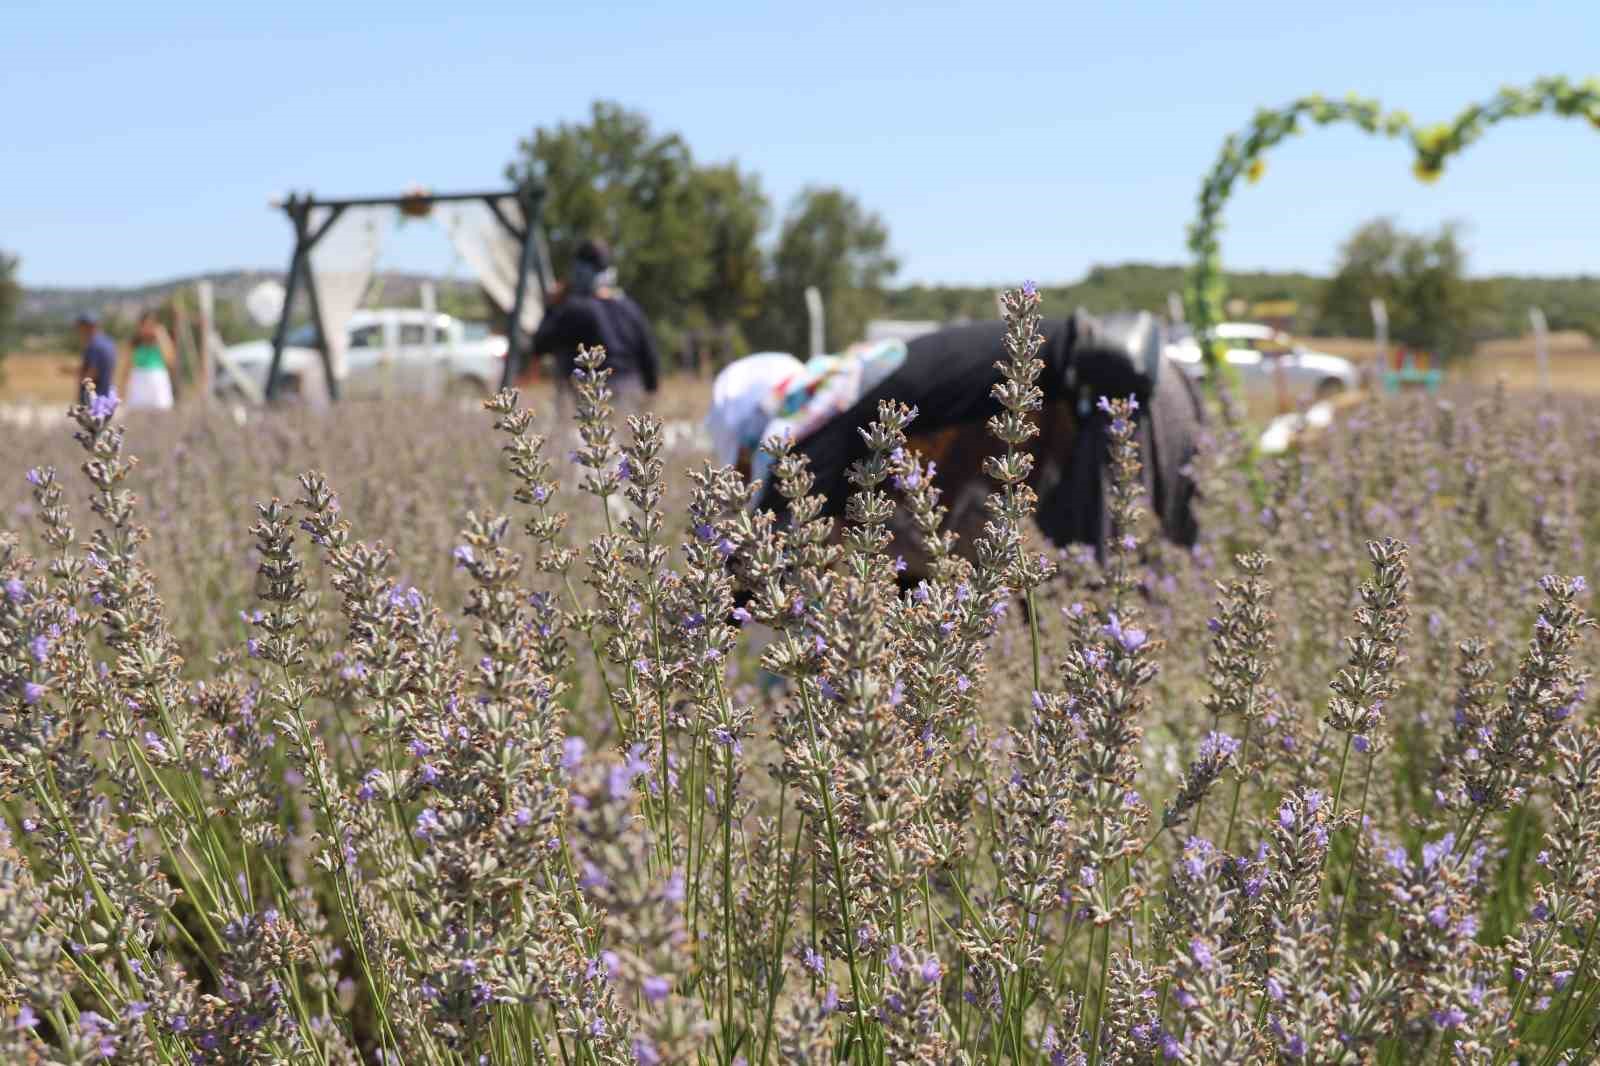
[0,0,1600,285]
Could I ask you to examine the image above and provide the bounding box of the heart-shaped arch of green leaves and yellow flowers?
[1186,77,1600,423]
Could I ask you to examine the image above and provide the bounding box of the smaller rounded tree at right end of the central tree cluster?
[762,187,899,352]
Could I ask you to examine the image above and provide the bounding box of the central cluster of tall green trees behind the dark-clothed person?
[507,101,899,357]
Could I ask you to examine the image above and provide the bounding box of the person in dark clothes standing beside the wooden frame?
[530,240,661,419]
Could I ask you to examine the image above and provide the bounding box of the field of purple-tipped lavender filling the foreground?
[0,295,1600,1066]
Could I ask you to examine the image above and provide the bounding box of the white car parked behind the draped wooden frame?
[214,307,507,399]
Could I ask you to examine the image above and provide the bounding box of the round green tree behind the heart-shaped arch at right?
[1317,218,1499,359]
